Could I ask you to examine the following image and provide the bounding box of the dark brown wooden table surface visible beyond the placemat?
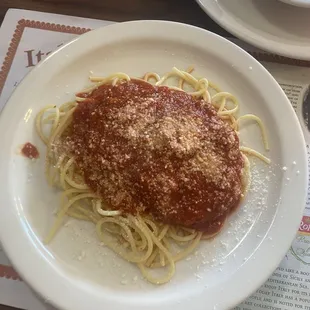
[0,0,231,310]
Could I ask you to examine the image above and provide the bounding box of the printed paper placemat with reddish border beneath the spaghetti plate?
[0,9,310,310]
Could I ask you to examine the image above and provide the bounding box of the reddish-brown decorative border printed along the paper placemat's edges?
[0,19,310,280]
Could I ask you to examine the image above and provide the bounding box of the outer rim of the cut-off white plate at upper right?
[196,0,310,61]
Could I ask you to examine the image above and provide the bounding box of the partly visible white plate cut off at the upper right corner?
[197,0,310,60]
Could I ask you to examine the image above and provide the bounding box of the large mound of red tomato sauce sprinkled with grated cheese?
[62,80,243,234]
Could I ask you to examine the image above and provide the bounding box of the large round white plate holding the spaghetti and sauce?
[0,21,307,310]
